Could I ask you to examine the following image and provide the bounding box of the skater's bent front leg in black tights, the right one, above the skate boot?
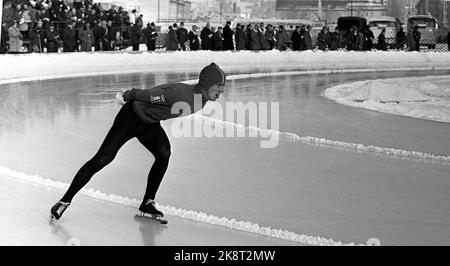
[138,123,171,202]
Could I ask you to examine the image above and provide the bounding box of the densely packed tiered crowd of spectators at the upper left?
[0,0,156,53]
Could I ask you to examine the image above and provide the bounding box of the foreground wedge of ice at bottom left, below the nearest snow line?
[0,174,298,246]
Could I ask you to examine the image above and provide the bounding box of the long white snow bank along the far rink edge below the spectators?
[0,50,450,80]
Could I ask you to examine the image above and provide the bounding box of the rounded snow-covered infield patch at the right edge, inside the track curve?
[324,76,450,123]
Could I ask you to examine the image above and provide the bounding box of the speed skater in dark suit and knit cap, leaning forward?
[51,63,226,219]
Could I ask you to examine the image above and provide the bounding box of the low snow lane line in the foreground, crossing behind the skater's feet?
[0,166,366,246]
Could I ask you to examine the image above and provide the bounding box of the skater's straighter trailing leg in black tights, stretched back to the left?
[61,105,137,202]
